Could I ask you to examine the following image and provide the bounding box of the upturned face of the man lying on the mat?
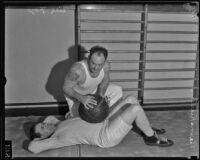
[35,122,56,139]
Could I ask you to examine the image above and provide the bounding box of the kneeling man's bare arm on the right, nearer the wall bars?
[98,61,110,97]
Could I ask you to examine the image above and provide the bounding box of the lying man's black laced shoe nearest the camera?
[144,132,174,147]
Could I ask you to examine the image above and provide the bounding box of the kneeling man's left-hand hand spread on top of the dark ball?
[81,95,97,109]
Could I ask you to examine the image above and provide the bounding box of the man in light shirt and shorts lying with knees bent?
[28,95,173,153]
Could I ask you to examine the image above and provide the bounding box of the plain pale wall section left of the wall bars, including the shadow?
[5,6,77,103]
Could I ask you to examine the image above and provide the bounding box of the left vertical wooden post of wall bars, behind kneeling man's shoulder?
[75,4,82,60]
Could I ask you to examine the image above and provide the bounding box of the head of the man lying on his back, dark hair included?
[30,122,56,140]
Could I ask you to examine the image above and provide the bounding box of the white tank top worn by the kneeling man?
[73,60,104,95]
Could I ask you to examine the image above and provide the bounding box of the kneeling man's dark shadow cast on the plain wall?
[45,45,86,115]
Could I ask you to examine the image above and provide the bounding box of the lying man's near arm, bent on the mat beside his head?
[28,137,61,153]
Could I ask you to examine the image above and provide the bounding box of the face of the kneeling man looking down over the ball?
[88,53,105,73]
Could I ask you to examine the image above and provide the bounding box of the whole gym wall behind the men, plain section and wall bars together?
[5,5,198,115]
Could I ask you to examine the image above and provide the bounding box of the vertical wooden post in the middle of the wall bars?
[138,4,148,105]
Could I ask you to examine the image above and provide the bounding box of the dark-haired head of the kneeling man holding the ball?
[88,46,108,73]
